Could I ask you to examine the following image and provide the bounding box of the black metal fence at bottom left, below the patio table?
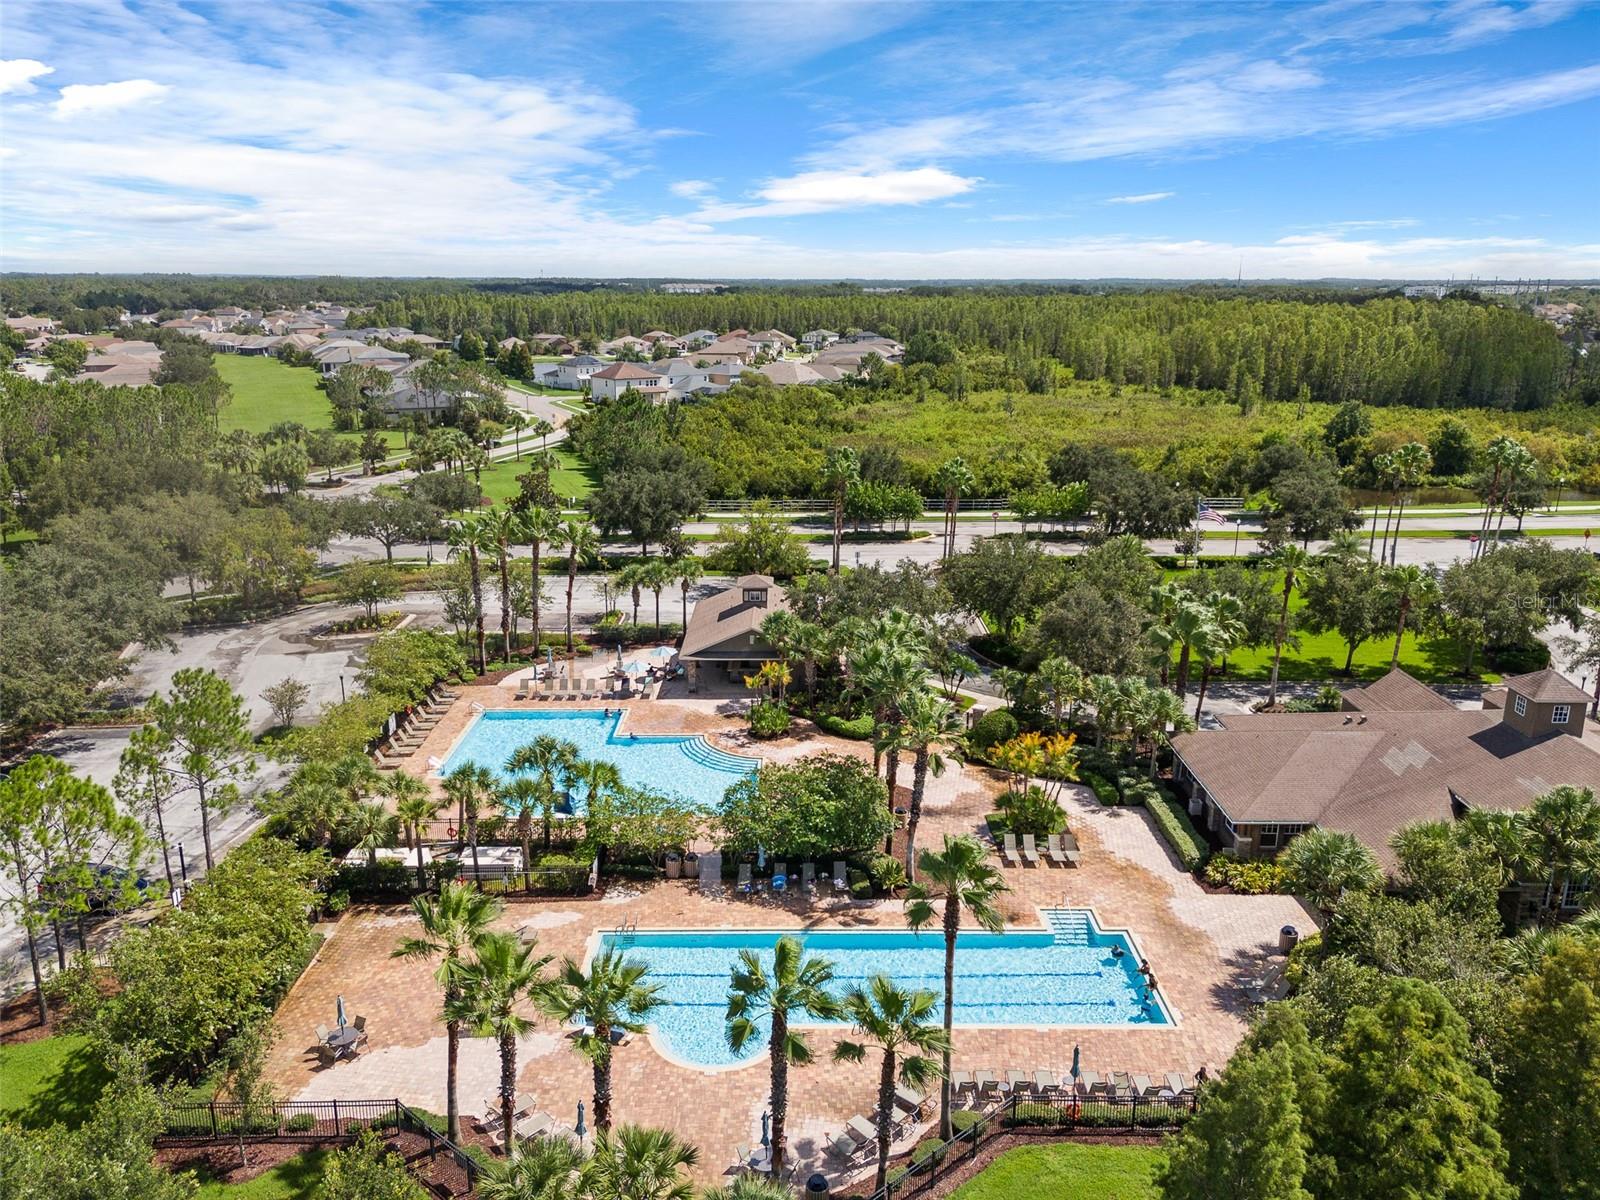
[157,1099,480,1181]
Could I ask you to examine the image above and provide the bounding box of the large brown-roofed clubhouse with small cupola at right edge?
[1173,669,1600,908]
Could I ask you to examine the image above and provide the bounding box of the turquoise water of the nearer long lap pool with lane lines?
[602,909,1171,1067]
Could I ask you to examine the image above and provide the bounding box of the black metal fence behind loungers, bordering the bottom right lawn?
[867,1093,1197,1200]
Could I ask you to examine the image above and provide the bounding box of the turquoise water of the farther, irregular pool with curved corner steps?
[440,710,760,808]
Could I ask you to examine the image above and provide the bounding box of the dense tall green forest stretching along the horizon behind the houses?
[373,288,1571,410]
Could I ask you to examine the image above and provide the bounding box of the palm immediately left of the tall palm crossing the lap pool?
[834,974,950,1192]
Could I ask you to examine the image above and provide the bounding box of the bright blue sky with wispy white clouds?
[0,0,1600,280]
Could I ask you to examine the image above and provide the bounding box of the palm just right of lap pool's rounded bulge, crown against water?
[728,938,840,1179]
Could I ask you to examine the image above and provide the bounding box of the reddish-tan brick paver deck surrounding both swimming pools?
[269,686,1317,1182]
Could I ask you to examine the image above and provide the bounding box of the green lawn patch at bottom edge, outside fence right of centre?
[950,1142,1163,1200]
